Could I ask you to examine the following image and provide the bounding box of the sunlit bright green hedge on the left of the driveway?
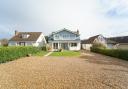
[0,46,40,63]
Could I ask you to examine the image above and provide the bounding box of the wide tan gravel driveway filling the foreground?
[0,53,128,89]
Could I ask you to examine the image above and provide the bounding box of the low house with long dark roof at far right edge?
[107,36,128,49]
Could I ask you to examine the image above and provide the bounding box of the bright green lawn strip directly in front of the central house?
[50,51,80,57]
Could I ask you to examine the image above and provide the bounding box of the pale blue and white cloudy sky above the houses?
[0,0,128,39]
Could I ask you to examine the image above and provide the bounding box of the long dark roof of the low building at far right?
[107,36,128,43]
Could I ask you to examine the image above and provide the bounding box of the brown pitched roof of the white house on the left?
[9,32,42,41]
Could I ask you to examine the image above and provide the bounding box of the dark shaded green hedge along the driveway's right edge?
[91,48,128,60]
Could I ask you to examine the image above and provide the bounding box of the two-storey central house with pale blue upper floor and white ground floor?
[48,28,81,51]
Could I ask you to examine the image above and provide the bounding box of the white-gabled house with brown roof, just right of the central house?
[81,35,107,50]
